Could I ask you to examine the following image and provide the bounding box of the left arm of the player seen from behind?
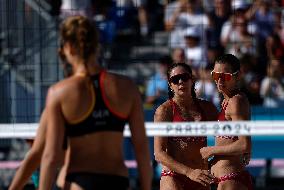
[39,87,64,190]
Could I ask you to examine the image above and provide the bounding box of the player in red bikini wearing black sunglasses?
[154,63,217,190]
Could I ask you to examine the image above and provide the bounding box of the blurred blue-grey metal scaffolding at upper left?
[0,0,62,123]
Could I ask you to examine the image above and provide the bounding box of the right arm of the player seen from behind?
[129,84,152,190]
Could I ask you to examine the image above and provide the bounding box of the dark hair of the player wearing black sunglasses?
[167,63,196,99]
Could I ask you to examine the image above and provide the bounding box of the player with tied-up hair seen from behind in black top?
[39,16,152,190]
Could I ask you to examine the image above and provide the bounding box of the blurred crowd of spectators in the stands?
[47,0,284,108]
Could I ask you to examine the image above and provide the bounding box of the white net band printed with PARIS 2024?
[0,120,284,139]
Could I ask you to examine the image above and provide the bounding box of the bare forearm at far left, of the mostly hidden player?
[9,110,47,190]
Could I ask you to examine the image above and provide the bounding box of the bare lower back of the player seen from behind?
[67,132,128,176]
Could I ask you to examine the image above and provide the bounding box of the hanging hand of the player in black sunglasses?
[186,169,214,186]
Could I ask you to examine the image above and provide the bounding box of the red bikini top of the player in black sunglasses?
[170,99,207,142]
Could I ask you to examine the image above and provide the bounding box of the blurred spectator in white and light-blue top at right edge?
[260,59,284,108]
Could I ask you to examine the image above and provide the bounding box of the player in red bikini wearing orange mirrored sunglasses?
[200,54,252,190]
